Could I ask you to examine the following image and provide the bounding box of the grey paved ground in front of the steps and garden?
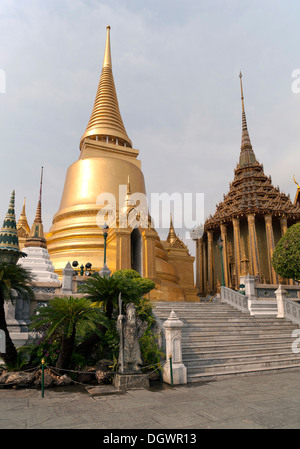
[0,372,300,429]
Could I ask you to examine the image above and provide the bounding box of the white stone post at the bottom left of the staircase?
[163,310,187,385]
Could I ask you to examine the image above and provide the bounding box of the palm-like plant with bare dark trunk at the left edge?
[0,263,34,367]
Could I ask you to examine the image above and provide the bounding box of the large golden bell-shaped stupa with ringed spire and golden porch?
[46,27,199,301]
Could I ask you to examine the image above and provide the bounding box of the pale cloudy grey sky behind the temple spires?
[0,0,300,254]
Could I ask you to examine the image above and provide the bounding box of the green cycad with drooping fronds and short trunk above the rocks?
[31,296,107,369]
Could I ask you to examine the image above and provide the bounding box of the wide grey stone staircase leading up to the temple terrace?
[153,302,300,382]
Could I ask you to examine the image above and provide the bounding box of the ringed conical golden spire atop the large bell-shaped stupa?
[80,26,132,148]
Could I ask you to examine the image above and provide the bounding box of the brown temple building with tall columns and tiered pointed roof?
[196,74,300,295]
